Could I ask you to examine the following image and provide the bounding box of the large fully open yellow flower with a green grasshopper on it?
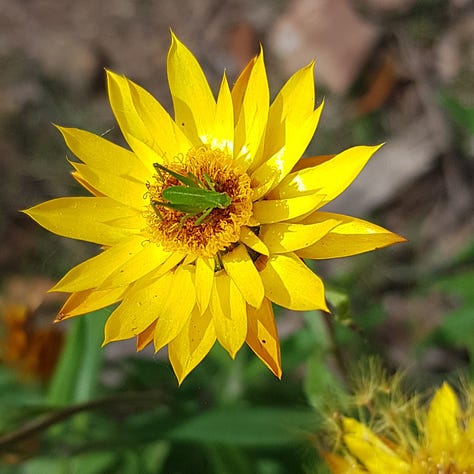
[25,35,404,382]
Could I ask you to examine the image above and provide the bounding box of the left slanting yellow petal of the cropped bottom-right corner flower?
[343,418,410,474]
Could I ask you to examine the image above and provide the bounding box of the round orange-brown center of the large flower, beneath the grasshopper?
[146,145,252,257]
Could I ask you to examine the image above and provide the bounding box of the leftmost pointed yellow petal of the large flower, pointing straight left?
[23,197,144,246]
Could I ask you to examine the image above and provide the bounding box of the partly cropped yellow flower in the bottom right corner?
[324,383,474,474]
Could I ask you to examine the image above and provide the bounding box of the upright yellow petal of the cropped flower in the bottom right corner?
[425,382,461,458]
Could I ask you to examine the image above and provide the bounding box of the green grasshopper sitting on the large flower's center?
[151,163,231,226]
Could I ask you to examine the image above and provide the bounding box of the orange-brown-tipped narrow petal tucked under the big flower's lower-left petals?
[55,286,128,322]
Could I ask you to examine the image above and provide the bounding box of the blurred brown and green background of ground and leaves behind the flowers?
[0,0,474,474]
